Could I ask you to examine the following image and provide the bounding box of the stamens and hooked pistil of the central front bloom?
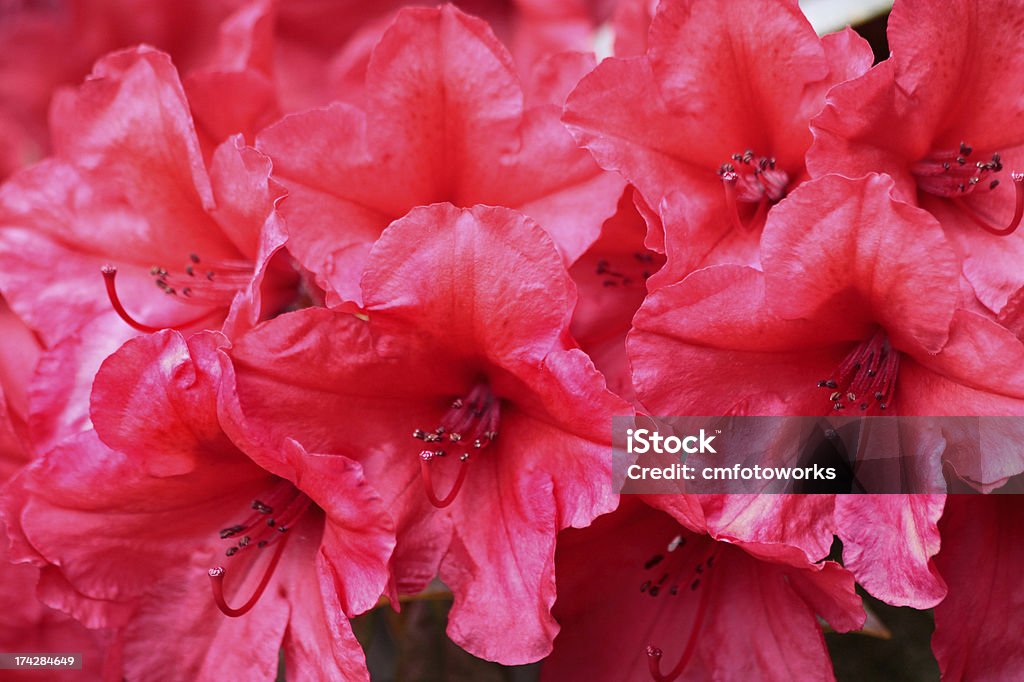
[413,383,501,509]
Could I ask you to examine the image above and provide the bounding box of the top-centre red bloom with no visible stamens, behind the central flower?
[258,6,622,300]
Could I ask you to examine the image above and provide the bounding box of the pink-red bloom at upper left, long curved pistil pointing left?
[0,48,296,450]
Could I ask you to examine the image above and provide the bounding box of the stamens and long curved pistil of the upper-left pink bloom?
[100,254,255,334]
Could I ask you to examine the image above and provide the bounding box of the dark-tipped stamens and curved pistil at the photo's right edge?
[910,142,1024,237]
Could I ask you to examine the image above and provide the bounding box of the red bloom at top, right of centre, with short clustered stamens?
[564,0,871,286]
